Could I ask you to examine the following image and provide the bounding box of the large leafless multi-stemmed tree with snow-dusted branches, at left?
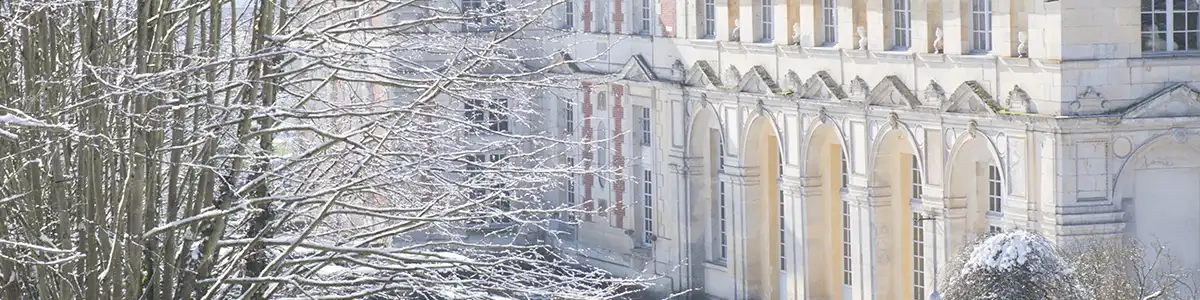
[0,0,641,299]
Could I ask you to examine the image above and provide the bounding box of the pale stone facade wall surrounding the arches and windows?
[532,0,1200,299]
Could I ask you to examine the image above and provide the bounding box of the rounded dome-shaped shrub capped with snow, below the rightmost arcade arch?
[943,230,1090,300]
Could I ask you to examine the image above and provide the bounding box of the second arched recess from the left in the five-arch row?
[739,110,792,299]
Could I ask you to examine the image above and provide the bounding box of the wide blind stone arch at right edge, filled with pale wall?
[1112,130,1200,274]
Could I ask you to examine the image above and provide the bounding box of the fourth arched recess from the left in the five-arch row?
[868,124,928,299]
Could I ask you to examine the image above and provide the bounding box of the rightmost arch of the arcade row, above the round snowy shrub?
[942,125,1009,251]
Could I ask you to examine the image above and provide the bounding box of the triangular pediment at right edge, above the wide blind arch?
[1121,84,1200,119]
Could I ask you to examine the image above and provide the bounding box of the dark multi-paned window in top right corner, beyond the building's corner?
[1141,0,1200,52]
